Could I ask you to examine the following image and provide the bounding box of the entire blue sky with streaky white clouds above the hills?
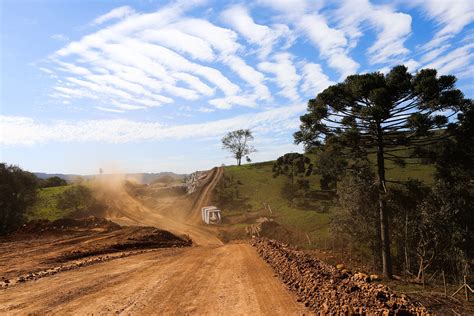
[0,0,474,174]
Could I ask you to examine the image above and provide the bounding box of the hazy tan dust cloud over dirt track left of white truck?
[83,165,224,244]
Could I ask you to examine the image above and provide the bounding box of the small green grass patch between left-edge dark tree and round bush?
[26,186,69,221]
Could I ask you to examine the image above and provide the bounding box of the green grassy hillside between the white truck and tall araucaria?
[216,154,434,247]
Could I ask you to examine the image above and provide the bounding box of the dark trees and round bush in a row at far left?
[0,163,104,235]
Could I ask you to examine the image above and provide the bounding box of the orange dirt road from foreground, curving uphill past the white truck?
[0,168,308,315]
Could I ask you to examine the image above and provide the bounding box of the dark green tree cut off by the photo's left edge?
[0,163,38,235]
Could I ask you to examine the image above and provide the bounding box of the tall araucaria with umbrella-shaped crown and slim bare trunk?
[294,66,469,278]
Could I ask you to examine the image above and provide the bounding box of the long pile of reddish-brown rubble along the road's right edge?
[252,238,430,315]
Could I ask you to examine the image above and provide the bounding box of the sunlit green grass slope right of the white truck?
[219,153,434,246]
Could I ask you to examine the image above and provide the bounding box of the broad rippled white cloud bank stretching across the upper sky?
[40,0,472,118]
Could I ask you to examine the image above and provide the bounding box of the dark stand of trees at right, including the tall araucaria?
[292,66,474,278]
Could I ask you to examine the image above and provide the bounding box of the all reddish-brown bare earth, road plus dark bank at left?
[0,168,308,315]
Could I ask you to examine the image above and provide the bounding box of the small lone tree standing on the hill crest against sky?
[222,129,256,166]
